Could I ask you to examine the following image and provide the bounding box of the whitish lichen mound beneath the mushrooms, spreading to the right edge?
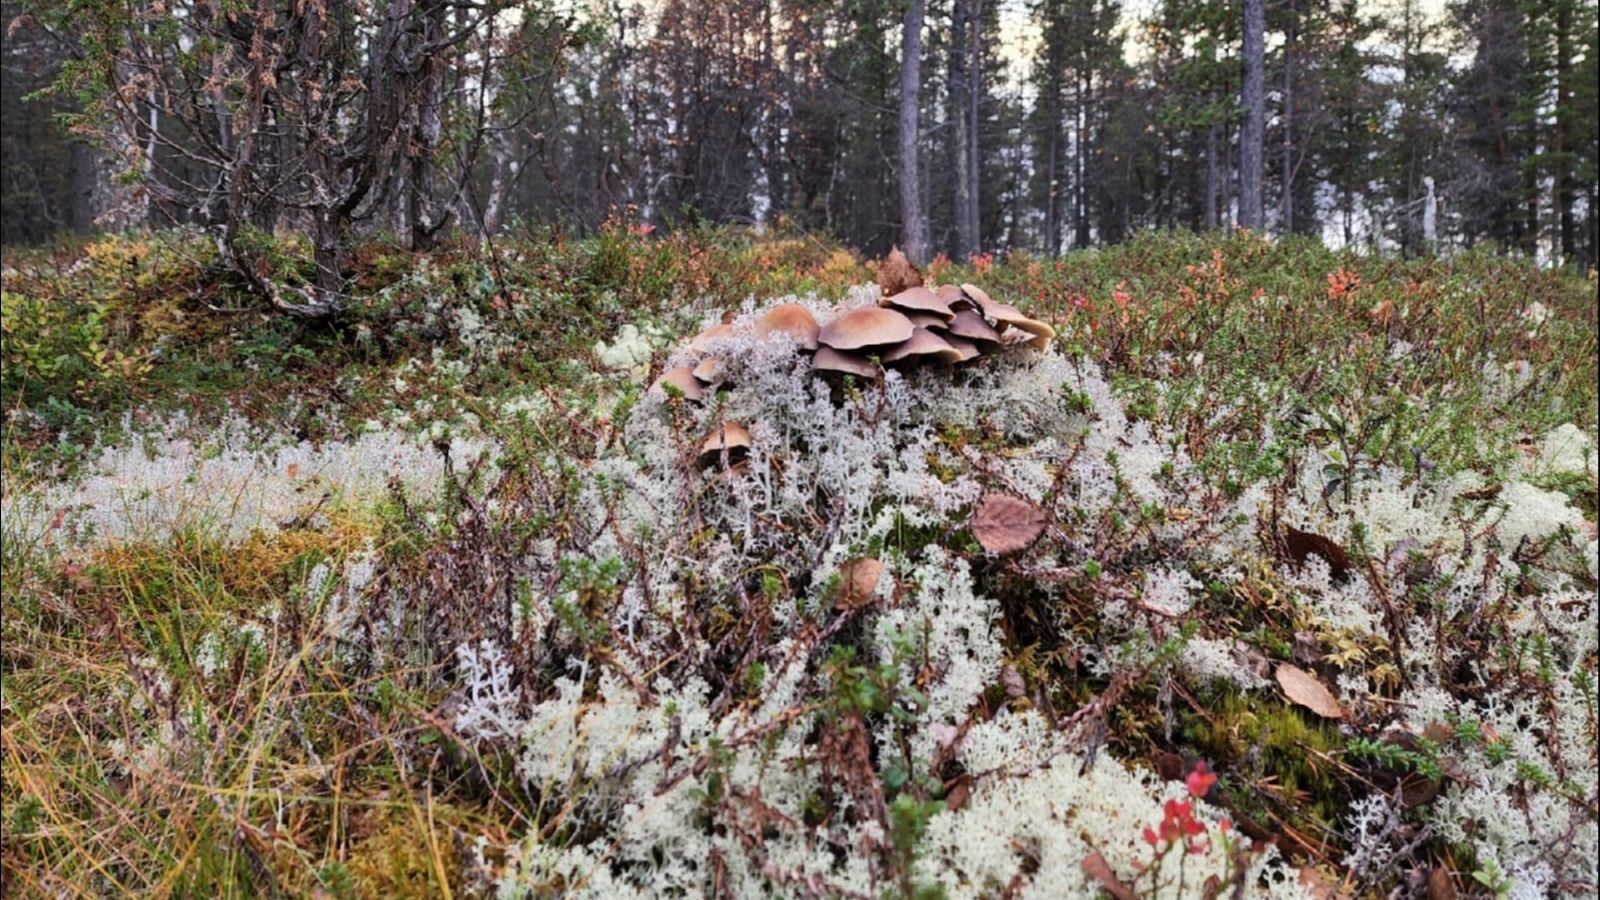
[456,288,1597,898]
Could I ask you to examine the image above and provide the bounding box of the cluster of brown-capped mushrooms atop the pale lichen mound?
[653,283,1056,402]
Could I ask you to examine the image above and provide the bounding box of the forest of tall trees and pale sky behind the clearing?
[0,0,1600,277]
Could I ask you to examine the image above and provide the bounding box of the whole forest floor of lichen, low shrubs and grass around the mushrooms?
[0,223,1597,897]
